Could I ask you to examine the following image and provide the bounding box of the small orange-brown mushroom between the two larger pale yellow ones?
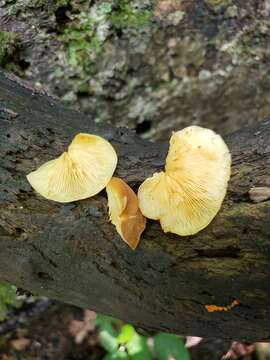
[106,177,146,250]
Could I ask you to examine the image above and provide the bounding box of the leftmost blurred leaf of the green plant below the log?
[95,314,118,353]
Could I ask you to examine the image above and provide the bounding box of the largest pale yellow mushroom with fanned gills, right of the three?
[138,126,231,236]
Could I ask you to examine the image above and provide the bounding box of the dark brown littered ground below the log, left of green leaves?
[0,303,105,360]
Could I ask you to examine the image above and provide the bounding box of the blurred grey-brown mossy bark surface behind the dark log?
[0,0,270,140]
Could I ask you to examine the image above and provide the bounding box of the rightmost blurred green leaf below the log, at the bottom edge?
[154,333,190,360]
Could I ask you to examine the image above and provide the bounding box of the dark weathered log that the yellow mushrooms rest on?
[0,69,270,341]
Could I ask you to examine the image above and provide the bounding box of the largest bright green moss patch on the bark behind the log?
[59,0,150,83]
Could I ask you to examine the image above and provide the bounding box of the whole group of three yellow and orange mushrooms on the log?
[27,126,231,250]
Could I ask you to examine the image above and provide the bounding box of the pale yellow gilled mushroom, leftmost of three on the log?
[27,133,117,203]
